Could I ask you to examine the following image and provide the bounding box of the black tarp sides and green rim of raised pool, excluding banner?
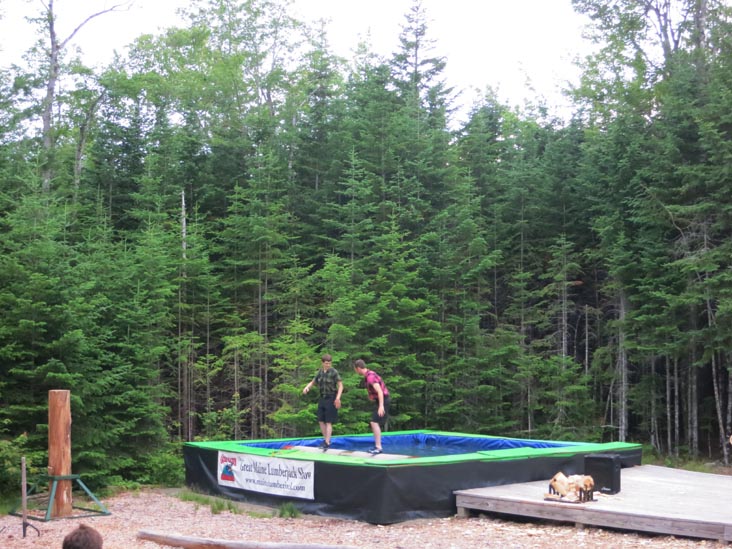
[184,431,641,524]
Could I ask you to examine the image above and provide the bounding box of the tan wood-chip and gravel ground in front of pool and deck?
[0,490,728,549]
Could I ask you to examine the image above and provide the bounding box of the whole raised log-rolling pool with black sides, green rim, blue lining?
[183,431,641,524]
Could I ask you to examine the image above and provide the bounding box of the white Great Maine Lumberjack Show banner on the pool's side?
[218,452,315,499]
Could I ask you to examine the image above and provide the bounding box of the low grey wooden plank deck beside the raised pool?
[455,465,732,542]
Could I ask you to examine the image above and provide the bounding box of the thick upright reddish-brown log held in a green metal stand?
[48,390,73,518]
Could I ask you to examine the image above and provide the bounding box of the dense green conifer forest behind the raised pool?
[0,0,732,487]
